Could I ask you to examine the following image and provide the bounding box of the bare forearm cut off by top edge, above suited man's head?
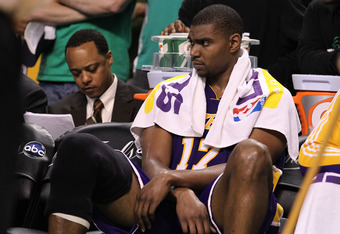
[57,0,132,15]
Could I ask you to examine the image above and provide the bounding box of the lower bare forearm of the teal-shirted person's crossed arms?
[27,1,90,25]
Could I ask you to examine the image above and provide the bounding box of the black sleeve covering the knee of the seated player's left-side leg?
[47,133,133,220]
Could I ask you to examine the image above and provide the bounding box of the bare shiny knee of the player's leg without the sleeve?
[235,139,272,177]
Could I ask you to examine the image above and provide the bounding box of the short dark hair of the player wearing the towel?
[191,4,243,37]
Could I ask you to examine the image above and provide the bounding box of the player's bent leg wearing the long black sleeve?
[46,134,140,233]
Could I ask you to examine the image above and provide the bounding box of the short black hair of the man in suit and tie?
[65,29,109,56]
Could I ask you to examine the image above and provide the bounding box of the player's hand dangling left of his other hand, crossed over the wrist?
[135,173,170,232]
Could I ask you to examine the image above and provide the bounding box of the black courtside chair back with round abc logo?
[10,123,54,227]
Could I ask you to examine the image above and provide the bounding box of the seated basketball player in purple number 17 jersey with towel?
[47,5,300,233]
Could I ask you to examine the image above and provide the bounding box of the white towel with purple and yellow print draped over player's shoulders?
[131,50,301,159]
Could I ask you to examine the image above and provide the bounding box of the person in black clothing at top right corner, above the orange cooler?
[298,0,340,75]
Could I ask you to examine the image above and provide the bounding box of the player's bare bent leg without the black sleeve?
[212,140,273,233]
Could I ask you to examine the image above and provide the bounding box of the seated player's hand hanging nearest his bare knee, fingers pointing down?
[173,188,216,233]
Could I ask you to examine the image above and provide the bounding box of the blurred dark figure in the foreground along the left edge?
[0,0,37,230]
